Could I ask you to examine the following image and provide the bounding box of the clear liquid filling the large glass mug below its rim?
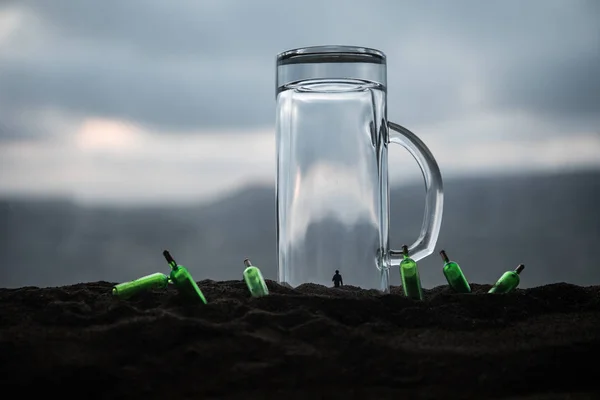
[277,79,390,289]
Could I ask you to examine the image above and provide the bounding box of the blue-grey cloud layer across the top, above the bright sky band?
[0,0,600,137]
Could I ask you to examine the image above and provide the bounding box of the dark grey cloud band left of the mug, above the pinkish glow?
[0,55,273,130]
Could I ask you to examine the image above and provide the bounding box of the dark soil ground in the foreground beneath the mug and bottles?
[0,280,600,400]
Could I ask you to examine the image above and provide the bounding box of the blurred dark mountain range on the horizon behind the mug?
[0,172,600,287]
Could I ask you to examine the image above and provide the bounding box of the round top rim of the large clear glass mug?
[277,45,386,65]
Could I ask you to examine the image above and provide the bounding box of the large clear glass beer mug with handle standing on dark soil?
[276,46,443,292]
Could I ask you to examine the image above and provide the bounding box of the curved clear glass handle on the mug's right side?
[388,121,444,267]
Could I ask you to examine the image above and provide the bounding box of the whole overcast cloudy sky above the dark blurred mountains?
[0,0,600,203]
